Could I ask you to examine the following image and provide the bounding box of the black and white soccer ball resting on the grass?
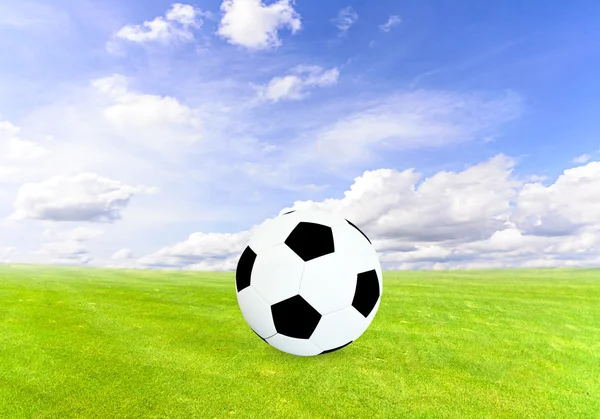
[236,211,383,356]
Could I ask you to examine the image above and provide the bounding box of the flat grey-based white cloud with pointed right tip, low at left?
[10,173,157,225]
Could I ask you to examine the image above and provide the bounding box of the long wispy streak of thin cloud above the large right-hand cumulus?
[312,91,521,164]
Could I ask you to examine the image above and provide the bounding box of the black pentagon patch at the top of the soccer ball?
[285,221,335,262]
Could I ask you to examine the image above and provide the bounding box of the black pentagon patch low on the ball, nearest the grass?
[271,295,321,339]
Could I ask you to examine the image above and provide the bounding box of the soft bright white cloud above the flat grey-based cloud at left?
[92,74,202,149]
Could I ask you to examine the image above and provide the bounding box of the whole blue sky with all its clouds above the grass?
[0,0,600,269]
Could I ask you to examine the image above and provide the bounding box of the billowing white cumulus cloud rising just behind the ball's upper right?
[284,155,519,244]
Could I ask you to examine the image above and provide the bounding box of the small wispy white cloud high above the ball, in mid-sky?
[258,66,340,102]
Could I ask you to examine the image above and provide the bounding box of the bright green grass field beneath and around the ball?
[0,266,600,419]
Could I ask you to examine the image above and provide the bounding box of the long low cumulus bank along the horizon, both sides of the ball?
[137,155,600,270]
